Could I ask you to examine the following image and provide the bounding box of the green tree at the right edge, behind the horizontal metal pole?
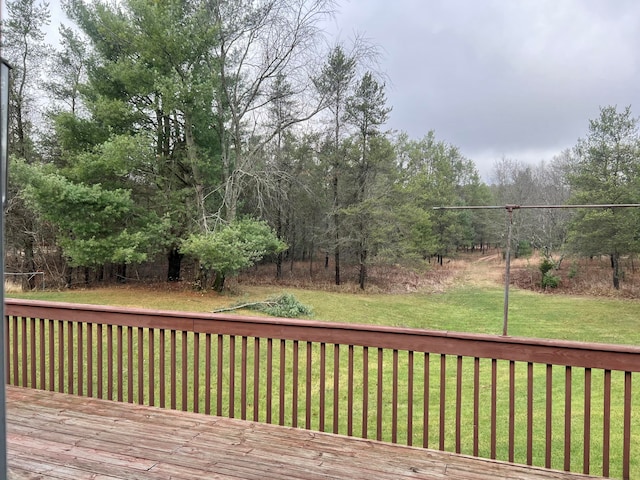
[568,106,640,289]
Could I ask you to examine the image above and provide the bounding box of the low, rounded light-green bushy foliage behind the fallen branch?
[180,218,287,276]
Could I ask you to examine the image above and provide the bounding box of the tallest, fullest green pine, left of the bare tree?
[63,0,221,281]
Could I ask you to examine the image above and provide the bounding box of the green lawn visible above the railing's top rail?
[13,286,640,345]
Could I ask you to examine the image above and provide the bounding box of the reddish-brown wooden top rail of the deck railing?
[5,298,640,372]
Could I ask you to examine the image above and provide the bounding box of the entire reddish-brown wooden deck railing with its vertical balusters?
[5,299,640,479]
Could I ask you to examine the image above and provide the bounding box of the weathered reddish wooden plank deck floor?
[7,387,597,480]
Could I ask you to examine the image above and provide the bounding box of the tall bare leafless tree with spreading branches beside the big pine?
[208,0,333,222]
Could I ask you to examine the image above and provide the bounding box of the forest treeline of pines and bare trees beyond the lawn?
[2,0,640,290]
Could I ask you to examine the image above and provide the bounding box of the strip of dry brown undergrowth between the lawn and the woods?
[235,253,640,298]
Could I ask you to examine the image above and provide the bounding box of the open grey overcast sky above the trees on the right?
[324,0,640,180]
